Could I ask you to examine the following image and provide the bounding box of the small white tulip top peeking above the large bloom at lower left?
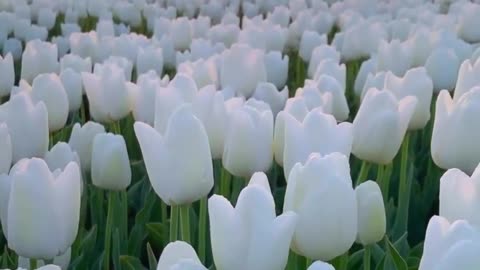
[44,142,81,172]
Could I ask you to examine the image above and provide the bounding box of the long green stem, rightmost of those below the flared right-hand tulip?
[395,132,412,237]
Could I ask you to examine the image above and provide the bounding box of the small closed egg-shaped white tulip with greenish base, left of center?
[92,133,132,190]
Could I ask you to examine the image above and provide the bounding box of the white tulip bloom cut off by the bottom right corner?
[418,216,480,270]
